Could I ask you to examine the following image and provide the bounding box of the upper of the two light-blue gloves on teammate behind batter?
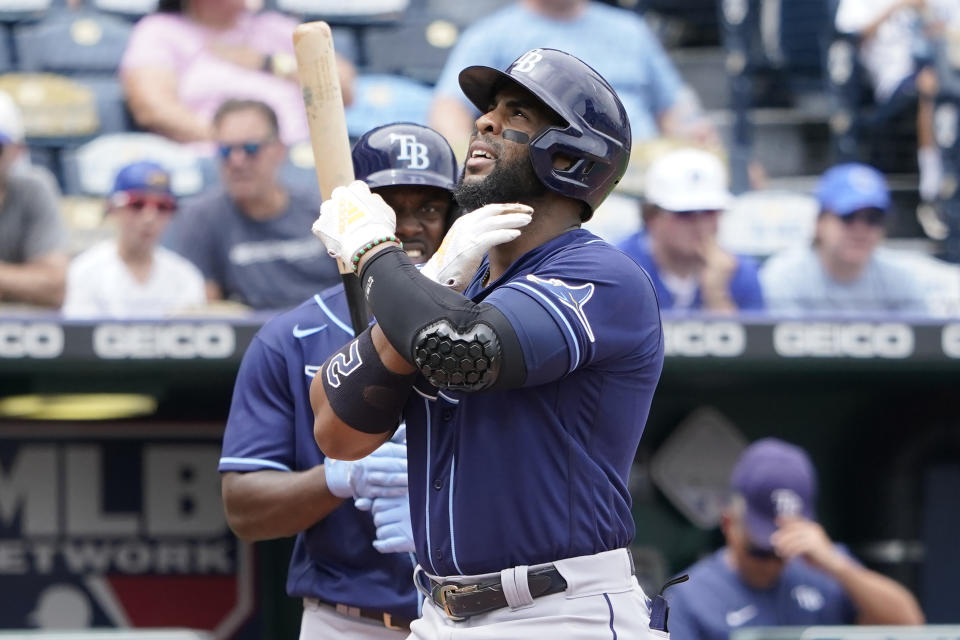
[323,442,407,498]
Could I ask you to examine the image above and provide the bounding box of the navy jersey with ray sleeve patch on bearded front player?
[404,229,663,575]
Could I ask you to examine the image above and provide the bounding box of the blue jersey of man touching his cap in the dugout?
[667,549,856,640]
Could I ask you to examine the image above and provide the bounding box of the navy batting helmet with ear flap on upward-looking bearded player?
[460,49,630,219]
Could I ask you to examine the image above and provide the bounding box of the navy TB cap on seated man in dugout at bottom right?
[730,438,817,549]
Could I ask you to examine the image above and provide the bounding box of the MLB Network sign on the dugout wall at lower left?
[0,426,253,638]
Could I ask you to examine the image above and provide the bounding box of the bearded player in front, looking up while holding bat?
[311,49,663,640]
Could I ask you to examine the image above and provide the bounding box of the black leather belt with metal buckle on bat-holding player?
[424,565,567,620]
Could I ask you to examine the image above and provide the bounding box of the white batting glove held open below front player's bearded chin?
[420,203,533,291]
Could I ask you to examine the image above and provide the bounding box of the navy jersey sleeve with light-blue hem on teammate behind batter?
[218,335,296,472]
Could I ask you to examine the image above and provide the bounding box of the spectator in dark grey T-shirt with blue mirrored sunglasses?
[167,100,340,309]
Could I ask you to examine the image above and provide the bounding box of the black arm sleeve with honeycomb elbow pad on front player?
[360,247,526,391]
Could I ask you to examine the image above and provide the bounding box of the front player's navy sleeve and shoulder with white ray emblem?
[486,245,663,386]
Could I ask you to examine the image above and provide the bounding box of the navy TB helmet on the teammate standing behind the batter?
[352,122,457,193]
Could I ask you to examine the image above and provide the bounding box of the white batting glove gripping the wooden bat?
[311,180,397,266]
